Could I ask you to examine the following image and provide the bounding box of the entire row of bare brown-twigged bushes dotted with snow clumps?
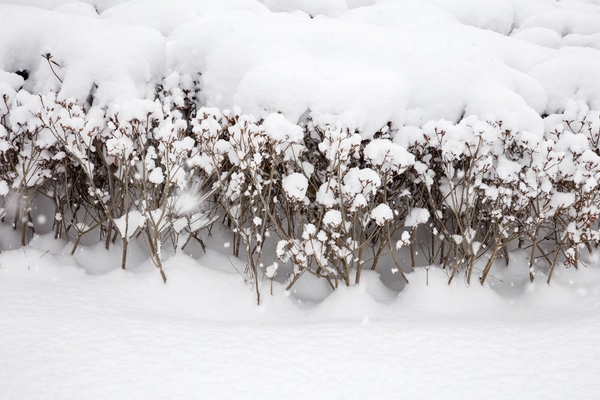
[0,78,600,296]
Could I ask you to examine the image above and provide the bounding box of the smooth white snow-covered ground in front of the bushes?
[0,237,600,399]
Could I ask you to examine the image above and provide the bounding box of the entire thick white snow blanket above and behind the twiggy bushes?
[0,0,600,137]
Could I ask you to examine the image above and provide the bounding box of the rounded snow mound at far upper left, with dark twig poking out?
[0,5,166,106]
